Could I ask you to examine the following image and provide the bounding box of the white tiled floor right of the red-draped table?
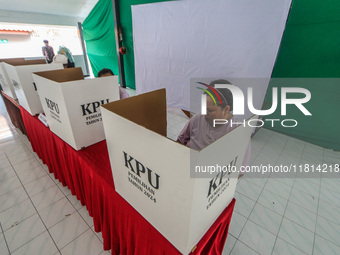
[223,129,340,255]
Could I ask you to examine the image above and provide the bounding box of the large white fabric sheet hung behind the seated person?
[132,0,291,115]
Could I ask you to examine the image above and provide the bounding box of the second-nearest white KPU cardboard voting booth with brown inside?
[33,67,119,150]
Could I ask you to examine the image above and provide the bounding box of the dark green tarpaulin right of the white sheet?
[264,0,340,150]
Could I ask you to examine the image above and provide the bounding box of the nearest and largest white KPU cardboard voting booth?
[102,89,253,254]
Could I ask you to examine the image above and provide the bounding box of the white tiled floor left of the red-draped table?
[0,99,110,255]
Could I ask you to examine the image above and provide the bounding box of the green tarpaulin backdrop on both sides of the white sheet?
[83,0,340,150]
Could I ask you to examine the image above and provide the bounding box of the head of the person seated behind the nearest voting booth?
[205,80,233,125]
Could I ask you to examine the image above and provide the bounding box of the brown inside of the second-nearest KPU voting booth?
[34,67,84,82]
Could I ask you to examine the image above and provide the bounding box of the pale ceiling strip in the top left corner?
[0,0,98,18]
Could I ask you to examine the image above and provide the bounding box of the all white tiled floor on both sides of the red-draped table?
[0,93,340,255]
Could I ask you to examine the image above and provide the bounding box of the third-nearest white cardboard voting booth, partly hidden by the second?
[4,59,64,115]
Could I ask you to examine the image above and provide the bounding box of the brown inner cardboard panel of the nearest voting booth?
[103,89,167,137]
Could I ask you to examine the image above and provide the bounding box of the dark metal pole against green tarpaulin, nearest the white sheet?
[112,0,126,88]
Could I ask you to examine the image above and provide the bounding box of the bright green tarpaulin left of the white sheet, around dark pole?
[83,0,173,89]
